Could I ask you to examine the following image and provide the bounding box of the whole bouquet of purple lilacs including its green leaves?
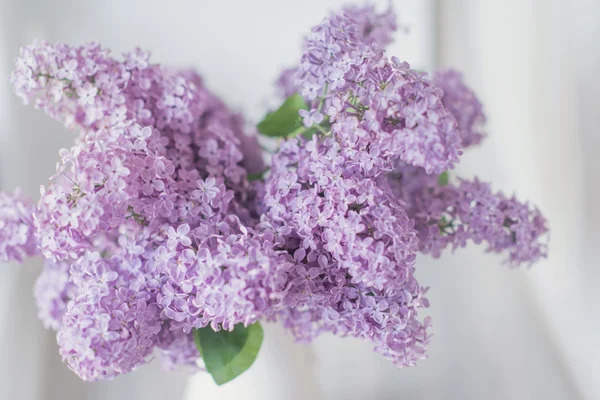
[0,6,548,384]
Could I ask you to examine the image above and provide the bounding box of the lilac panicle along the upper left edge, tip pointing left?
[11,42,260,189]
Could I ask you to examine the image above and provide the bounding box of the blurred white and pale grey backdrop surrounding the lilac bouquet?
[0,0,600,400]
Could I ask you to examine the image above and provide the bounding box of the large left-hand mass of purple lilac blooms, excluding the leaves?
[8,43,287,380]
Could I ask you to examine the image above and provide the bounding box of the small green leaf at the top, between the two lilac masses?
[258,94,308,137]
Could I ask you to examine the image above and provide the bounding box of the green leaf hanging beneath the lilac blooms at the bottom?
[194,322,263,385]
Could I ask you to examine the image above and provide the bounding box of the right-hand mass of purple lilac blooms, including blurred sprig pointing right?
[261,3,547,366]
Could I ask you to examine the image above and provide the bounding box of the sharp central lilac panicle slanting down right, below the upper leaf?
[263,137,417,289]
